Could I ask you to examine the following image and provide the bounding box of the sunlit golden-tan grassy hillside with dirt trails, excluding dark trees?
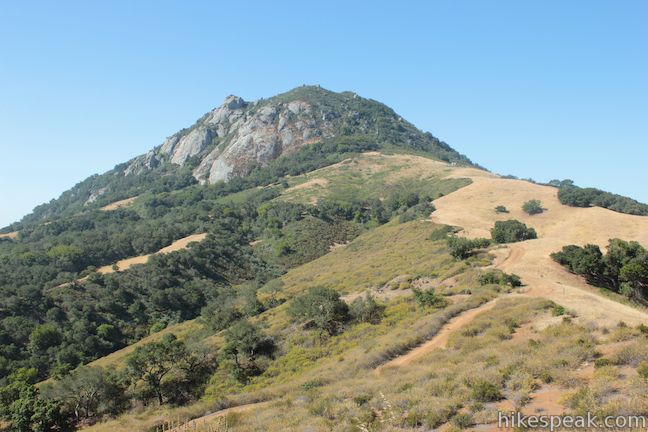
[73,159,648,431]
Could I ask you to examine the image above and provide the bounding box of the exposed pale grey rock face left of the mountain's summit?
[124,92,335,183]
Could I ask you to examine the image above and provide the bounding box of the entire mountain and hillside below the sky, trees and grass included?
[0,87,648,432]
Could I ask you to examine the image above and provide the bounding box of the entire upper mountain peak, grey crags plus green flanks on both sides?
[11,86,472,224]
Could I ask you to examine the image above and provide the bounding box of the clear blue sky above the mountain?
[0,0,648,226]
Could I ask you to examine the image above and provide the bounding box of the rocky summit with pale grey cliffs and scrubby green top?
[123,86,468,183]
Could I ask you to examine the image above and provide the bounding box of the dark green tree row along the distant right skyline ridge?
[549,180,648,216]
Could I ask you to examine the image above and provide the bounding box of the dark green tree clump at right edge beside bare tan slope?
[551,239,648,304]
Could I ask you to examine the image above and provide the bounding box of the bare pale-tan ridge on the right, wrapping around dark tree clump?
[432,168,648,325]
